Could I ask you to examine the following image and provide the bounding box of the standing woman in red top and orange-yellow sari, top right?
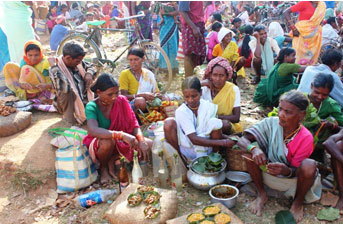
[284,1,326,65]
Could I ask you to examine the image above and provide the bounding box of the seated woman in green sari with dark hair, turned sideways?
[253,48,306,107]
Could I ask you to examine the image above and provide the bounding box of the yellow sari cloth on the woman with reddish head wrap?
[212,82,243,133]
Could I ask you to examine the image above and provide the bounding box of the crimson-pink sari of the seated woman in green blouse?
[83,95,139,163]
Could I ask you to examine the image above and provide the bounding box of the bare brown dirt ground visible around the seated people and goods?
[0,30,343,223]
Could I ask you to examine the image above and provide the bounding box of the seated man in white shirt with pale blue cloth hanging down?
[249,25,280,84]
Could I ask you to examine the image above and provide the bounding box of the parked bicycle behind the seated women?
[56,12,172,93]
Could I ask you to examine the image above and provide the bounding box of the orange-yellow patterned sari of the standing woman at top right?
[289,2,326,66]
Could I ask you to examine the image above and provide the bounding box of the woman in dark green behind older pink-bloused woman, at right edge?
[304,73,343,162]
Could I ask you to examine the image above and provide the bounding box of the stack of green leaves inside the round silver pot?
[193,152,224,173]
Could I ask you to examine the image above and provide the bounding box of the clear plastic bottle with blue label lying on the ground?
[74,189,117,208]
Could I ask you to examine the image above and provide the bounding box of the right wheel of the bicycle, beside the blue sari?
[142,42,173,93]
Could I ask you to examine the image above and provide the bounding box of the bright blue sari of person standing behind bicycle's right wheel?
[158,16,179,69]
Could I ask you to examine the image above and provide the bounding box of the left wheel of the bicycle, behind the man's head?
[56,34,102,72]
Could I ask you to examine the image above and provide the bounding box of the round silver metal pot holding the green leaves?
[187,156,227,191]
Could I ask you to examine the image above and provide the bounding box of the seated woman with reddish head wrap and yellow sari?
[201,57,243,134]
